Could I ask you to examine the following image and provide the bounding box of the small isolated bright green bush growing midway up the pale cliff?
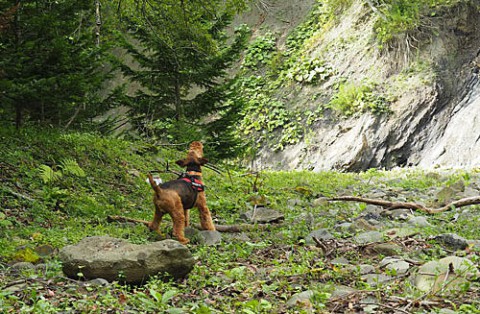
[327,82,390,116]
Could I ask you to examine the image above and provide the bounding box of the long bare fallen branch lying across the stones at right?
[327,196,480,214]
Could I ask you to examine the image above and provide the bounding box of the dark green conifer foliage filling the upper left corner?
[0,0,116,127]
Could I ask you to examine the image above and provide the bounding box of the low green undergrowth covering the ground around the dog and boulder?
[0,129,480,313]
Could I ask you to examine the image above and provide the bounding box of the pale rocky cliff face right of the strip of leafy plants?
[244,1,480,171]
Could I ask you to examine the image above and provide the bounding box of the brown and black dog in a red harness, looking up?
[148,142,215,244]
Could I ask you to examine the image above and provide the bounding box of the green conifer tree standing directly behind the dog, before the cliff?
[117,0,248,154]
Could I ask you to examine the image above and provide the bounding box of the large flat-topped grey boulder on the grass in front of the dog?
[59,236,194,284]
